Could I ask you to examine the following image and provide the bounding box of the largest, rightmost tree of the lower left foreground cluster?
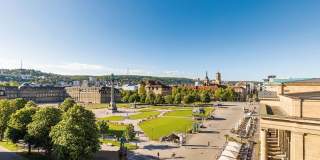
[50,105,100,160]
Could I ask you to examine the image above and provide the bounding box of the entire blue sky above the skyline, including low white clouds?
[0,0,320,80]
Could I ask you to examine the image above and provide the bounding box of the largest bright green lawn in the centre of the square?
[140,117,192,140]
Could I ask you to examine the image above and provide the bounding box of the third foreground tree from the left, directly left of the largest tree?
[27,107,62,154]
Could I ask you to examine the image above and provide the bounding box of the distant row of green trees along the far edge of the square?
[122,87,235,104]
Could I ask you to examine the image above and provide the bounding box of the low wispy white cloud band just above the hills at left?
[0,58,192,77]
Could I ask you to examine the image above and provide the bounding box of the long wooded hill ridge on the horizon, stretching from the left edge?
[0,69,193,85]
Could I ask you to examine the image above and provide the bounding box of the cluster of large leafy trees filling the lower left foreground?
[0,99,101,160]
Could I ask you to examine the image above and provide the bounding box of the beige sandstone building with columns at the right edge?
[259,79,320,160]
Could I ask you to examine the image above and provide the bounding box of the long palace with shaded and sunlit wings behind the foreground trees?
[0,83,121,103]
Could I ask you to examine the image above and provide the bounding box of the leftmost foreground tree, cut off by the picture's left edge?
[0,100,16,141]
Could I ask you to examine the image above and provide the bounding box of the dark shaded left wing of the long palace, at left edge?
[0,84,67,103]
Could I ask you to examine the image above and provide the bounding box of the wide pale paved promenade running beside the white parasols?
[129,102,250,160]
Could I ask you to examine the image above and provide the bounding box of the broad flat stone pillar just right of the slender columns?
[290,131,304,160]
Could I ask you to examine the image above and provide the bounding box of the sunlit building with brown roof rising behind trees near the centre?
[141,80,172,95]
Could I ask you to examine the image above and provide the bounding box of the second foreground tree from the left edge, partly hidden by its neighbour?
[5,107,37,153]
